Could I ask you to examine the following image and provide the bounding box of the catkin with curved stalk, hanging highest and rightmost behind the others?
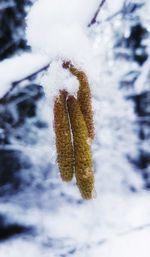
[64,62,94,139]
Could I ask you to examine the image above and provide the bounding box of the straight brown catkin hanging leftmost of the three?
[54,91,74,181]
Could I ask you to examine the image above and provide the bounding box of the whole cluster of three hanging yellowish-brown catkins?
[54,63,94,200]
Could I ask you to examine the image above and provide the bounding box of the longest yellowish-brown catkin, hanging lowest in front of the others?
[67,96,94,200]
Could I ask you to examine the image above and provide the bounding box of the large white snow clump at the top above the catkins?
[26,0,99,66]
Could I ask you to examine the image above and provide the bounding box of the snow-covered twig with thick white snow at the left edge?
[0,53,49,102]
